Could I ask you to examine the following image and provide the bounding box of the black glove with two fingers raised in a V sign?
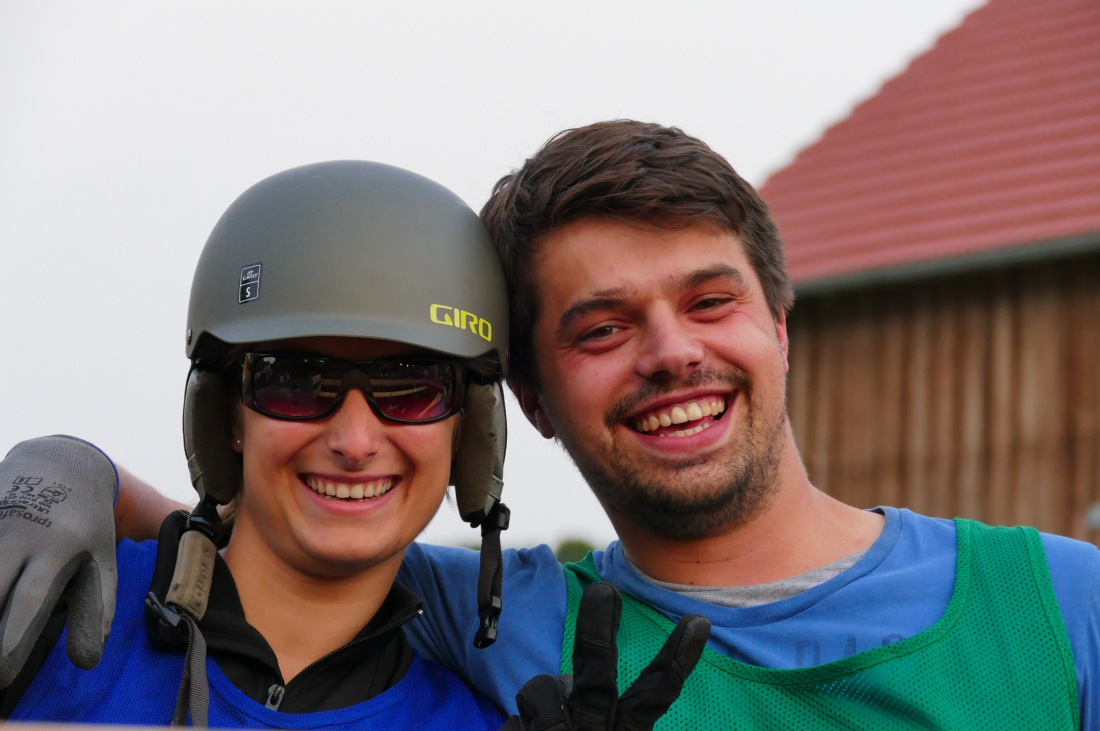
[501,582,711,731]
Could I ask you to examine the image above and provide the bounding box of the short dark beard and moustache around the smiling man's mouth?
[558,374,787,541]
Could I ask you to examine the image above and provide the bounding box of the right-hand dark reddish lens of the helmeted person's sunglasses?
[370,361,458,422]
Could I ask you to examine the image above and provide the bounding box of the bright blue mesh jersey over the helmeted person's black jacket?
[11,541,504,731]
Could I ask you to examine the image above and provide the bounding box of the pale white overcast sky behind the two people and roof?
[0,0,982,545]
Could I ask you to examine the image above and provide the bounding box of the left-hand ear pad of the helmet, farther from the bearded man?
[184,365,243,505]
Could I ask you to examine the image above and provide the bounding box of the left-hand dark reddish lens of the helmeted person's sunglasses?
[251,355,341,419]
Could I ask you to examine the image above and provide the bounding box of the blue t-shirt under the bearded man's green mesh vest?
[399,508,1100,729]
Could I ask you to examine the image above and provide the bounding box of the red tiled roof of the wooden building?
[761,0,1100,285]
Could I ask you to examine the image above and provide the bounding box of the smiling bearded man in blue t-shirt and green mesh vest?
[2,121,1100,729]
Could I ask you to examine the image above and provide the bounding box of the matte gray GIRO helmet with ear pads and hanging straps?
[167,160,508,646]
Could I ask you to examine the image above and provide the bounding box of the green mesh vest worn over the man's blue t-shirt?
[562,520,1080,731]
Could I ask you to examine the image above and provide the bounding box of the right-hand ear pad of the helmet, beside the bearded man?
[451,380,508,525]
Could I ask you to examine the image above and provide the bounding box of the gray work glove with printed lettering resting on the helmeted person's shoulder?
[0,435,119,688]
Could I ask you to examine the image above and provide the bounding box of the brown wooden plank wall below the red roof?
[788,255,1100,541]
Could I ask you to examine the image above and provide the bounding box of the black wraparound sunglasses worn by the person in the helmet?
[241,353,465,424]
